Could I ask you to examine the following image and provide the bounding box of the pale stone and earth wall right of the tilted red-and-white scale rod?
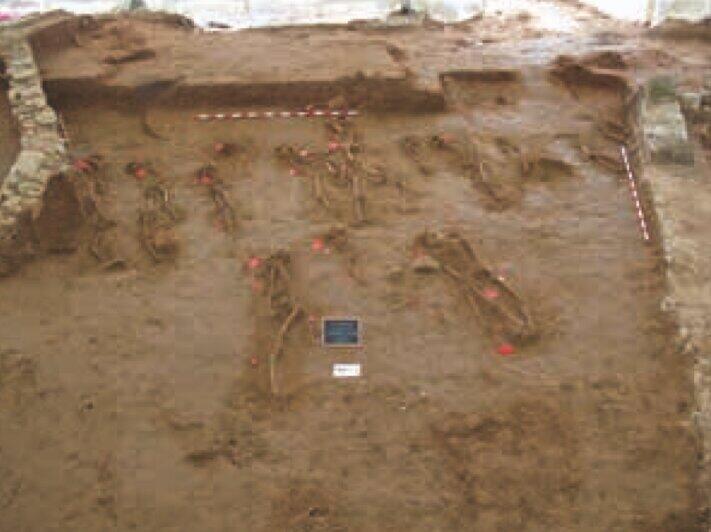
[638,78,711,510]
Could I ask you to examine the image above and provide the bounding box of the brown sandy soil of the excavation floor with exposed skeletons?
[0,4,705,531]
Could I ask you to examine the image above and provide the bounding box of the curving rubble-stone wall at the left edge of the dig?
[0,21,68,274]
